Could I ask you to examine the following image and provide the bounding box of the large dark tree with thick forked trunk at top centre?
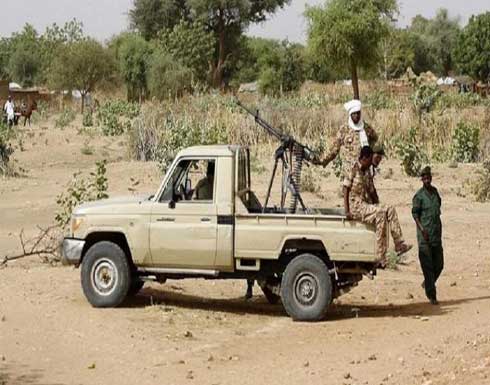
[129,0,291,87]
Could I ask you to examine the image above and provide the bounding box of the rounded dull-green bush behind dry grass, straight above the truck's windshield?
[148,49,192,100]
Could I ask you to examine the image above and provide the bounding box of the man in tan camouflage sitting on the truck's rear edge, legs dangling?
[343,146,412,268]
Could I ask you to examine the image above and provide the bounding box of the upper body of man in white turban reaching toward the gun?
[316,99,378,182]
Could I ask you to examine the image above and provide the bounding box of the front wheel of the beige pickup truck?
[80,241,131,307]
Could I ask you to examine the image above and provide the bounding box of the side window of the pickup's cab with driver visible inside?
[160,159,216,202]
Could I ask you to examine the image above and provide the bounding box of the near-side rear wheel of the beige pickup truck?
[281,254,332,321]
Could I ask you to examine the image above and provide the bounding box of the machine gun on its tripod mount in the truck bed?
[236,99,314,214]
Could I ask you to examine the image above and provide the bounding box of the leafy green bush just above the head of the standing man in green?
[395,128,429,177]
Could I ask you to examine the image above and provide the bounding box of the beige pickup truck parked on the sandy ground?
[63,145,379,321]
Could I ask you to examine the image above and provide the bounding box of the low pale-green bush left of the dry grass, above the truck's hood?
[96,99,140,136]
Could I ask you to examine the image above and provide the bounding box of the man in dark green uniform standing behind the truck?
[412,167,444,305]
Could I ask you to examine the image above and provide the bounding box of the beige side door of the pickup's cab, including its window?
[150,158,218,268]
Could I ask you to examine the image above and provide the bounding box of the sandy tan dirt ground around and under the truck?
[0,118,490,385]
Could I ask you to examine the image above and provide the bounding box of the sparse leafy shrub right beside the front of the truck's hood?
[55,160,109,228]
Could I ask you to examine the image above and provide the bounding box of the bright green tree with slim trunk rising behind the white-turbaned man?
[306,0,398,99]
